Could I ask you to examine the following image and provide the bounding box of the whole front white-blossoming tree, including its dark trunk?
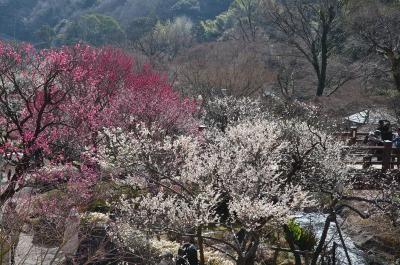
[98,100,352,264]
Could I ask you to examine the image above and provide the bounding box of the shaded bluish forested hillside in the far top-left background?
[0,0,233,43]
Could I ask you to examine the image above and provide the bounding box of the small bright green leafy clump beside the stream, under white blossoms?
[288,219,318,251]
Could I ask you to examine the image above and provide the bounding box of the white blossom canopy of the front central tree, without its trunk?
[104,116,337,229]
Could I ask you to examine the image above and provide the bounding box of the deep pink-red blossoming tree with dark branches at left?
[0,42,196,205]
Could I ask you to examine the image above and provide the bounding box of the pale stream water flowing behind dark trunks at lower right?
[294,213,368,265]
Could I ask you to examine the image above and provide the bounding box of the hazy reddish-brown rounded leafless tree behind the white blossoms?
[175,41,273,99]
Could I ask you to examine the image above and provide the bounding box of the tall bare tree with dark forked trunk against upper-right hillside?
[265,0,351,96]
